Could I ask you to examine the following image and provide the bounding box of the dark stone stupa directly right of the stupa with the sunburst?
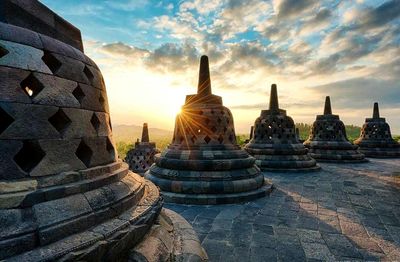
[244,84,320,172]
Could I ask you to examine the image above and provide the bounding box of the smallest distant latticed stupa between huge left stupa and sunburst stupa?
[125,123,160,175]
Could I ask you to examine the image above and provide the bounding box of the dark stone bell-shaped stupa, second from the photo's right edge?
[304,96,367,163]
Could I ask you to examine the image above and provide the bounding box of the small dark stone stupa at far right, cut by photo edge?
[354,103,400,158]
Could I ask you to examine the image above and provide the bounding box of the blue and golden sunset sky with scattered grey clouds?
[41,0,400,134]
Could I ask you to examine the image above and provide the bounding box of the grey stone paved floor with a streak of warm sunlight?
[165,160,400,262]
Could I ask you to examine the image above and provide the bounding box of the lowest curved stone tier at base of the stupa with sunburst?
[161,180,273,205]
